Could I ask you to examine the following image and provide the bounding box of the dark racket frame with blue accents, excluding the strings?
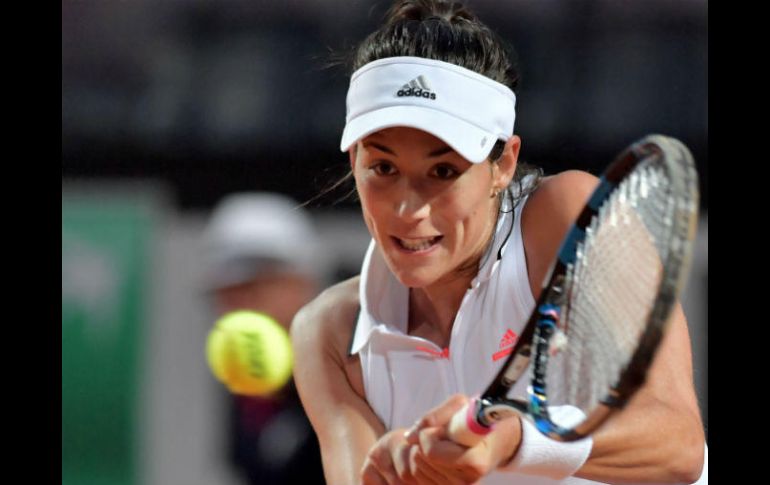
[467,135,699,441]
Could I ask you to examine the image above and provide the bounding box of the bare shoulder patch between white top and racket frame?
[521,170,599,298]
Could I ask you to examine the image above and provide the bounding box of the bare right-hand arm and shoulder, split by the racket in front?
[522,171,704,483]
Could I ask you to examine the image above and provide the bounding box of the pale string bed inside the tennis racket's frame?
[546,159,673,413]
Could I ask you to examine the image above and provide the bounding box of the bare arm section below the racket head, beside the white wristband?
[576,305,705,483]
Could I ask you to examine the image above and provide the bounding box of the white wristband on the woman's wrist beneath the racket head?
[500,406,594,480]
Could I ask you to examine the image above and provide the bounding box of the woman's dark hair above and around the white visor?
[310,0,542,206]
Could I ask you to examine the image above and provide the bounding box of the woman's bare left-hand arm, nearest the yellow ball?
[291,278,385,485]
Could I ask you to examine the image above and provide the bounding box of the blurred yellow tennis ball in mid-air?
[206,310,294,396]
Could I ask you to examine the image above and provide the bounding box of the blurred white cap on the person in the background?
[204,192,323,290]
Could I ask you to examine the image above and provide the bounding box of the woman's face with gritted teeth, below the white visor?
[350,127,513,287]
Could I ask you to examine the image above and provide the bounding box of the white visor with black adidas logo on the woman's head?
[340,57,516,163]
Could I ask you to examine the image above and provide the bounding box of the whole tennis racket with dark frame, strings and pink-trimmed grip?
[448,135,698,446]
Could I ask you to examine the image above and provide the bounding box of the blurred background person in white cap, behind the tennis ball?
[203,193,325,485]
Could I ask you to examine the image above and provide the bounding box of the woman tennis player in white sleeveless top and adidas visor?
[292,0,707,485]
